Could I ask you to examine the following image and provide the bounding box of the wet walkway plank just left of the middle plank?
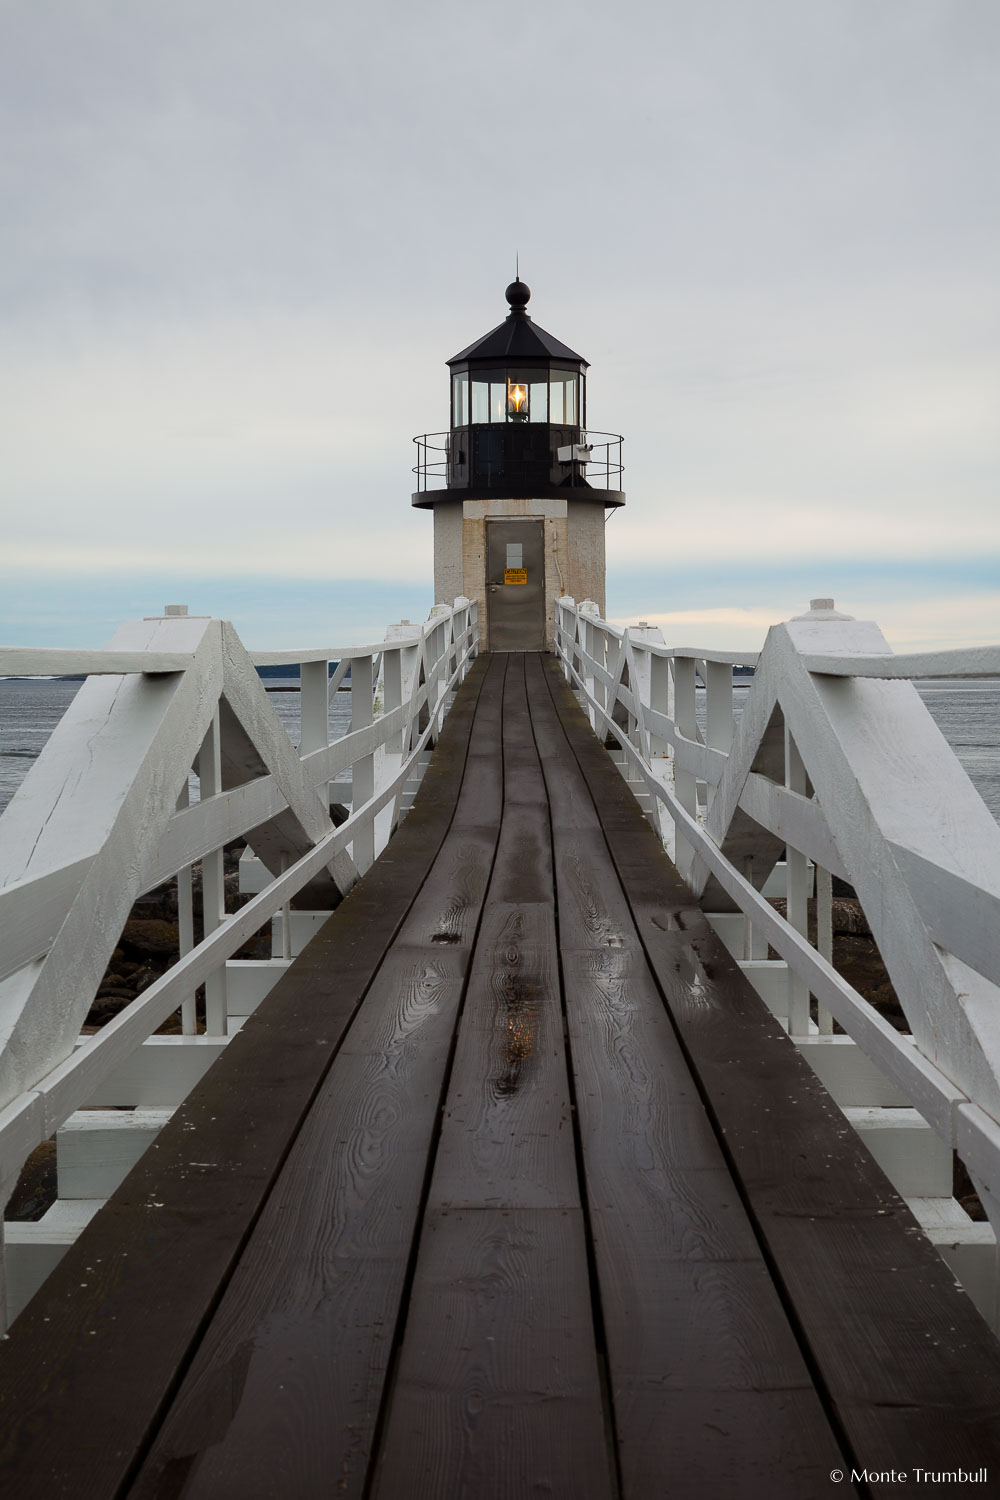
[125,668,504,1500]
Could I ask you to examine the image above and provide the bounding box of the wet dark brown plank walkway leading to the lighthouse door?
[0,656,1000,1500]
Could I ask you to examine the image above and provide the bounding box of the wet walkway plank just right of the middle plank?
[532,657,840,1500]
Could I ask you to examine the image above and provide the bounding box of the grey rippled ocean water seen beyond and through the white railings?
[0,678,1000,837]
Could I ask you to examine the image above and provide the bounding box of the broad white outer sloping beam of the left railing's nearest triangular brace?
[0,620,222,1103]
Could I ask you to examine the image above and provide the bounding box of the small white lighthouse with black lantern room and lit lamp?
[412,276,625,651]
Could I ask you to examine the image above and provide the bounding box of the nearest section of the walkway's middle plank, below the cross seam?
[373,1208,615,1500]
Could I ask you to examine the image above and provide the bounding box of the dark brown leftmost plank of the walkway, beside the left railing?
[0,663,486,1500]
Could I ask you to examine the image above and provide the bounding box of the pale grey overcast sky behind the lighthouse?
[0,0,1000,648]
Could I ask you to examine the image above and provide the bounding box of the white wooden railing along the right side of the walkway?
[556,599,1000,1326]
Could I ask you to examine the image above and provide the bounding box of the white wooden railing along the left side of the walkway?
[0,599,478,1326]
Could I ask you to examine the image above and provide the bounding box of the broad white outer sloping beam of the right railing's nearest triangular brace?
[772,623,1000,1115]
